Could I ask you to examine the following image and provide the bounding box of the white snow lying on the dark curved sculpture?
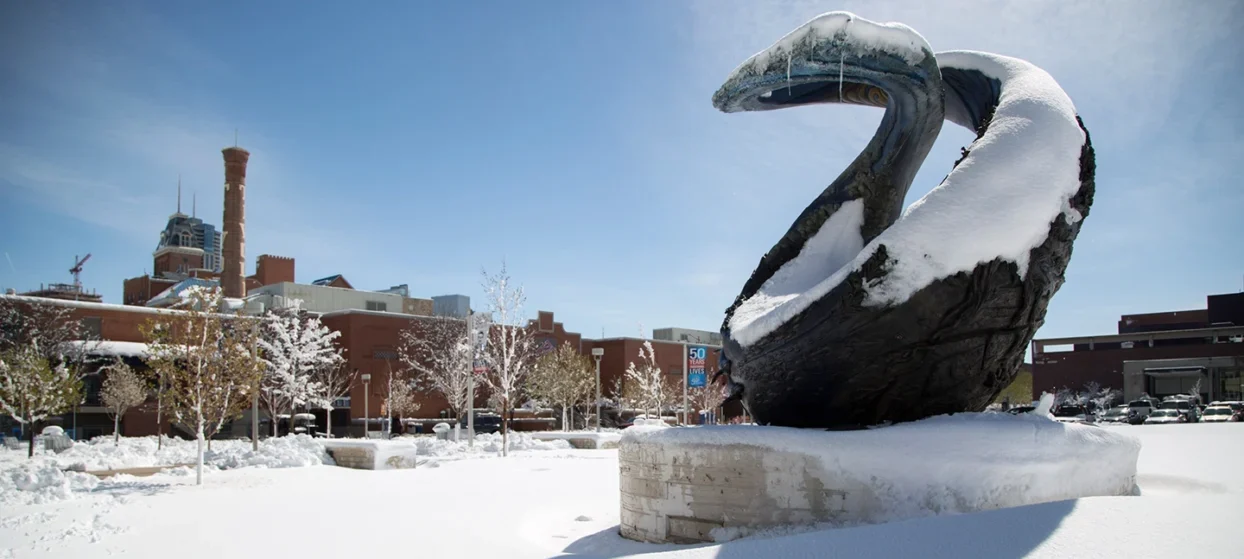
[730,28,1085,346]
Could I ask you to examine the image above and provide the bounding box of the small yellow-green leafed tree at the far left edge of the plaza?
[0,341,82,457]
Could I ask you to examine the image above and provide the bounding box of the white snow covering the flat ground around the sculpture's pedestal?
[0,423,1244,558]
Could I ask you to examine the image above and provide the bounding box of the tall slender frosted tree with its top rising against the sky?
[483,261,535,456]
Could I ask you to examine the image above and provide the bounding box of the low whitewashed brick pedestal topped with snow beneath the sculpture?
[618,413,1141,543]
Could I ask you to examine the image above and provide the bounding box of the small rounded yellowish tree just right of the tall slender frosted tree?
[526,342,596,431]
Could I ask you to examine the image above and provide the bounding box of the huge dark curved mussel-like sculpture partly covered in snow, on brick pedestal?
[713,12,1093,427]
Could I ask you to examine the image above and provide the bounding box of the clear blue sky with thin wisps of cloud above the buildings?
[0,0,1244,337]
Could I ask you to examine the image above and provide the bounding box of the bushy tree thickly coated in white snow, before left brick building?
[259,305,343,437]
